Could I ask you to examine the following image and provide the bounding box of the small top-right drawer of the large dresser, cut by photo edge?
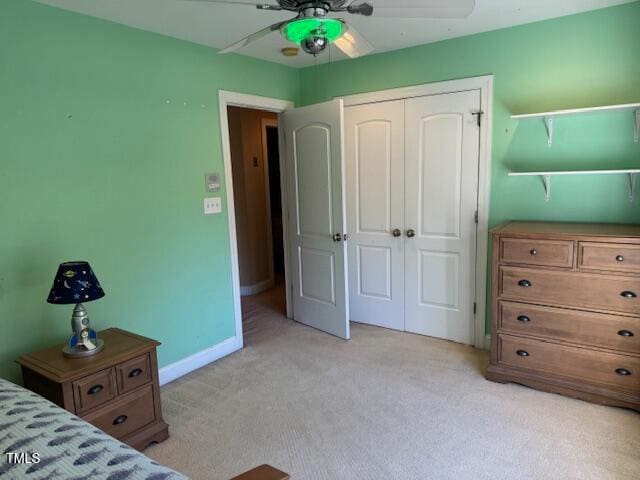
[580,242,640,273]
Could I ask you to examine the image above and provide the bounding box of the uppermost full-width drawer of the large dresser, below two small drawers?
[499,266,640,314]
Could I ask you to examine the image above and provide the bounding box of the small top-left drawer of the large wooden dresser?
[500,238,573,268]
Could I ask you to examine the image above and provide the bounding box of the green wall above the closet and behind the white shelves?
[301,2,640,327]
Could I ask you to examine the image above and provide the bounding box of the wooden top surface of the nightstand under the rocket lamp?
[16,328,160,382]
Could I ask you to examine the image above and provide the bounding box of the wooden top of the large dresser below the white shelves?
[491,222,640,239]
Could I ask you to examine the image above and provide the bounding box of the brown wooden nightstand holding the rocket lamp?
[16,328,169,450]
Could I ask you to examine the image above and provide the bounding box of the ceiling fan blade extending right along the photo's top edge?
[373,0,476,18]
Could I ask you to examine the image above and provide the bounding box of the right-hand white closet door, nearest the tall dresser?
[405,90,480,344]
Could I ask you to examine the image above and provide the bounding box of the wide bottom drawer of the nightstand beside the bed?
[83,385,155,438]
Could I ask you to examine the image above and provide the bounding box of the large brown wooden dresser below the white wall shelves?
[486,222,640,410]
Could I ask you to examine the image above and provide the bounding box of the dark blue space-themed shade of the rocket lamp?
[47,262,104,305]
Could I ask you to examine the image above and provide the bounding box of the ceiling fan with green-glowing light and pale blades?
[185,0,475,58]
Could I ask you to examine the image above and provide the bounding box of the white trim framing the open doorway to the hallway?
[218,90,293,348]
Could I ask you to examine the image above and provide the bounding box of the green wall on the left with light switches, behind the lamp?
[0,0,299,379]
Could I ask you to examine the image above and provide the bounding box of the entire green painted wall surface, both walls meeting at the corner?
[0,0,640,379]
